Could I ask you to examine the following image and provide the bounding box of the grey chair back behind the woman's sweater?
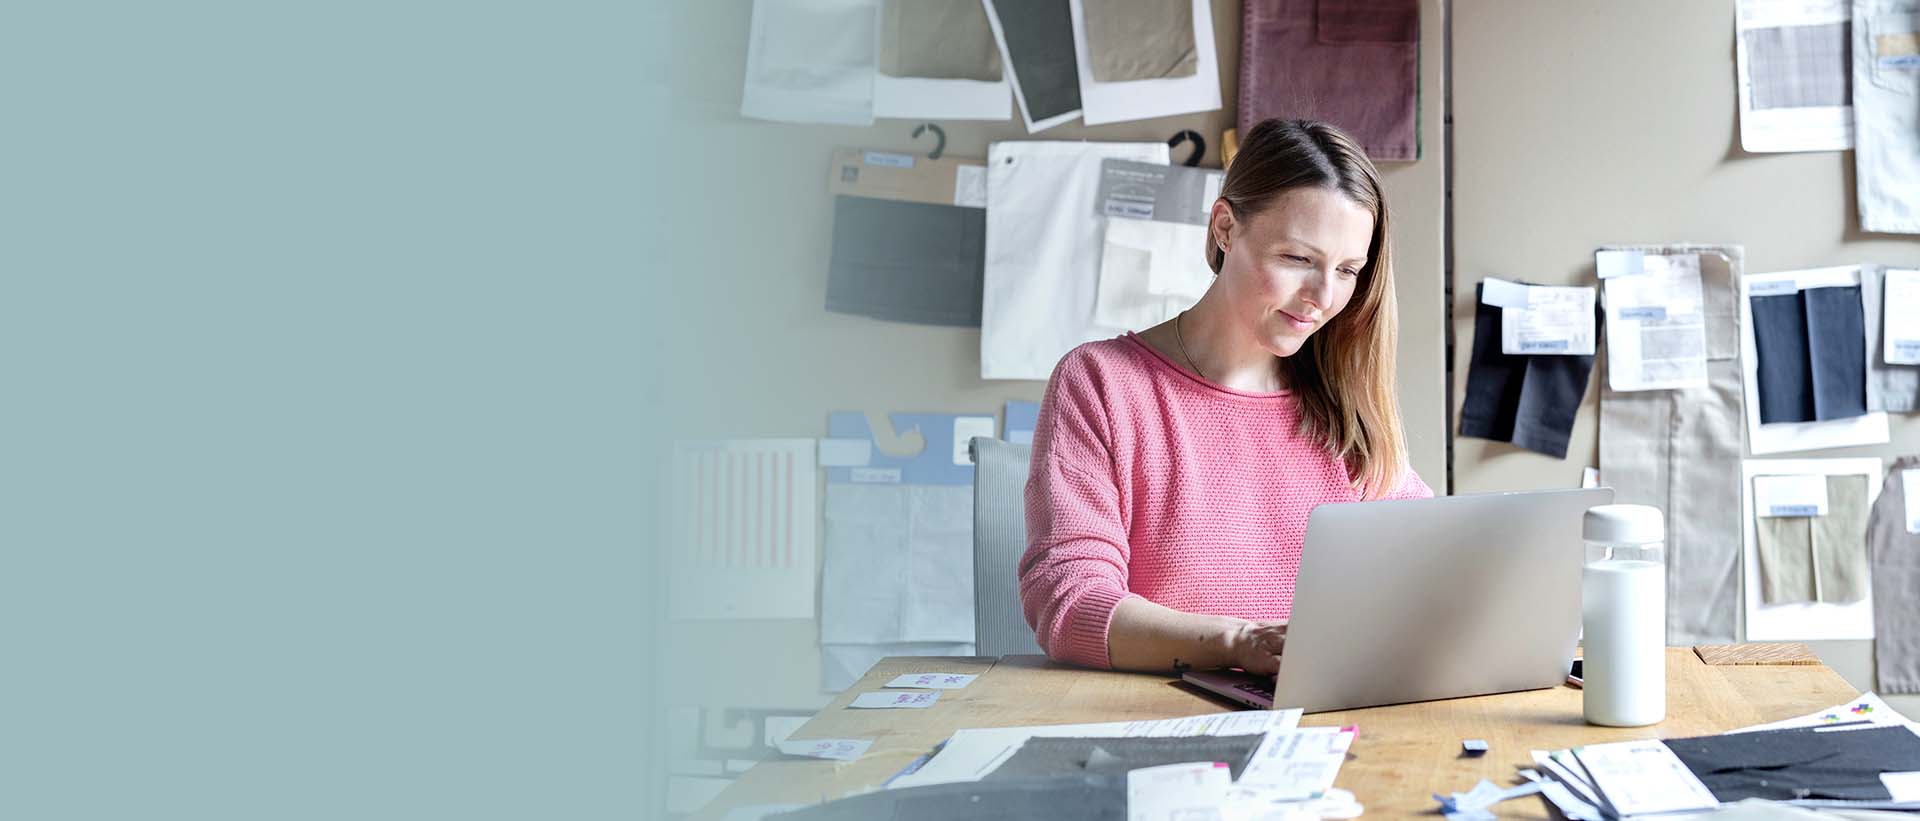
[968,435,1041,656]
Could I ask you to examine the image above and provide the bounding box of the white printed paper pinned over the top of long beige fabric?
[1596,251,1707,391]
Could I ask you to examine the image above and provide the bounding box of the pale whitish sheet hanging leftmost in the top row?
[739,0,879,125]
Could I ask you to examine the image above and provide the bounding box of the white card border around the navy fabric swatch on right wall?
[1740,272,1889,457]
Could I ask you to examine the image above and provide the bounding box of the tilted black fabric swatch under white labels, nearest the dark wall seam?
[1459,284,1599,458]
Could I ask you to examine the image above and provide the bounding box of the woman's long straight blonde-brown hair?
[1208,119,1407,499]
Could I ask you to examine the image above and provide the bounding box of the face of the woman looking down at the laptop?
[1212,188,1373,357]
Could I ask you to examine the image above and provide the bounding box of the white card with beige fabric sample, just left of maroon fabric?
[1069,0,1221,125]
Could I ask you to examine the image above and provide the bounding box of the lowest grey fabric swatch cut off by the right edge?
[1866,457,1920,694]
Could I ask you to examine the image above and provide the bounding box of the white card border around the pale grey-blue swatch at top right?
[1734,0,1853,153]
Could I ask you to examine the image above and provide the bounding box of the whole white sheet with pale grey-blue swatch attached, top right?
[1734,0,1853,152]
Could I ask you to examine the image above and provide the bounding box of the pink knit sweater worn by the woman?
[1020,334,1432,668]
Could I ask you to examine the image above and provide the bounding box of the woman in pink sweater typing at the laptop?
[1020,119,1432,673]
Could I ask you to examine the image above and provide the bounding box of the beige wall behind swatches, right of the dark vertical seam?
[1452,0,1920,714]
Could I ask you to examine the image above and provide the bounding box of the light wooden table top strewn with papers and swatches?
[695,648,1859,819]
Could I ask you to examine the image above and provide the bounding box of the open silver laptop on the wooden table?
[1185,487,1613,714]
